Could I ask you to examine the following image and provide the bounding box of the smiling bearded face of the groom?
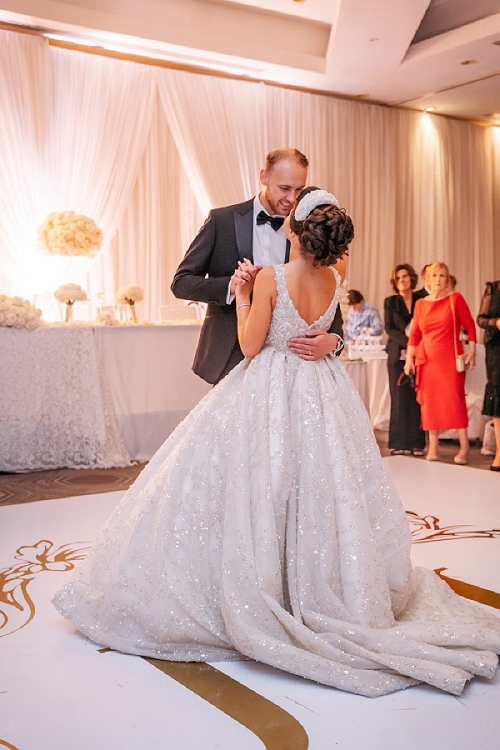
[260,161,307,216]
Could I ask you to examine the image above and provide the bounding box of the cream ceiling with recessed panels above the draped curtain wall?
[0,0,500,125]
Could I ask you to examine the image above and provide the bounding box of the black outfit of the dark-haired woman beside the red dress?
[384,292,425,451]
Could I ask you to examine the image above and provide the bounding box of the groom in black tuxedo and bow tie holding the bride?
[171,148,343,383]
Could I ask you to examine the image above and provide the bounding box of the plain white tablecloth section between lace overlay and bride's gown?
[95,325,212,461]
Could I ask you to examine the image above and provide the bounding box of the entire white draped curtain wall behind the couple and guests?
[0,32,500,318]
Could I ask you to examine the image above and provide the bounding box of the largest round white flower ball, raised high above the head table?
[37,211,102,258]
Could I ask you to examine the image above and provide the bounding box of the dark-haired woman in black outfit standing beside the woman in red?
[384,263,425,456]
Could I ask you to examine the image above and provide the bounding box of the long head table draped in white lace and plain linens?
[0,324,211,472]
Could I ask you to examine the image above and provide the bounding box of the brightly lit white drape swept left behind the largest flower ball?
[0,32,156,314]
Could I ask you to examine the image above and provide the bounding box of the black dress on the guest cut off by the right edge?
[477,281,500,417]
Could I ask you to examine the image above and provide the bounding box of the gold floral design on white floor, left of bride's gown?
[0,539,90,637]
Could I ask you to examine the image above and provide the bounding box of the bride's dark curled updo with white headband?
[290,187,354,266]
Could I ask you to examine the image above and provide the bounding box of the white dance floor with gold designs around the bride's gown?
[0,457,500,750]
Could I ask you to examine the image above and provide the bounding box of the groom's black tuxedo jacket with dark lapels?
[170,198,343,383]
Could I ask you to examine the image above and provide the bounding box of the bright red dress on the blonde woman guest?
[408,292,476,430]
